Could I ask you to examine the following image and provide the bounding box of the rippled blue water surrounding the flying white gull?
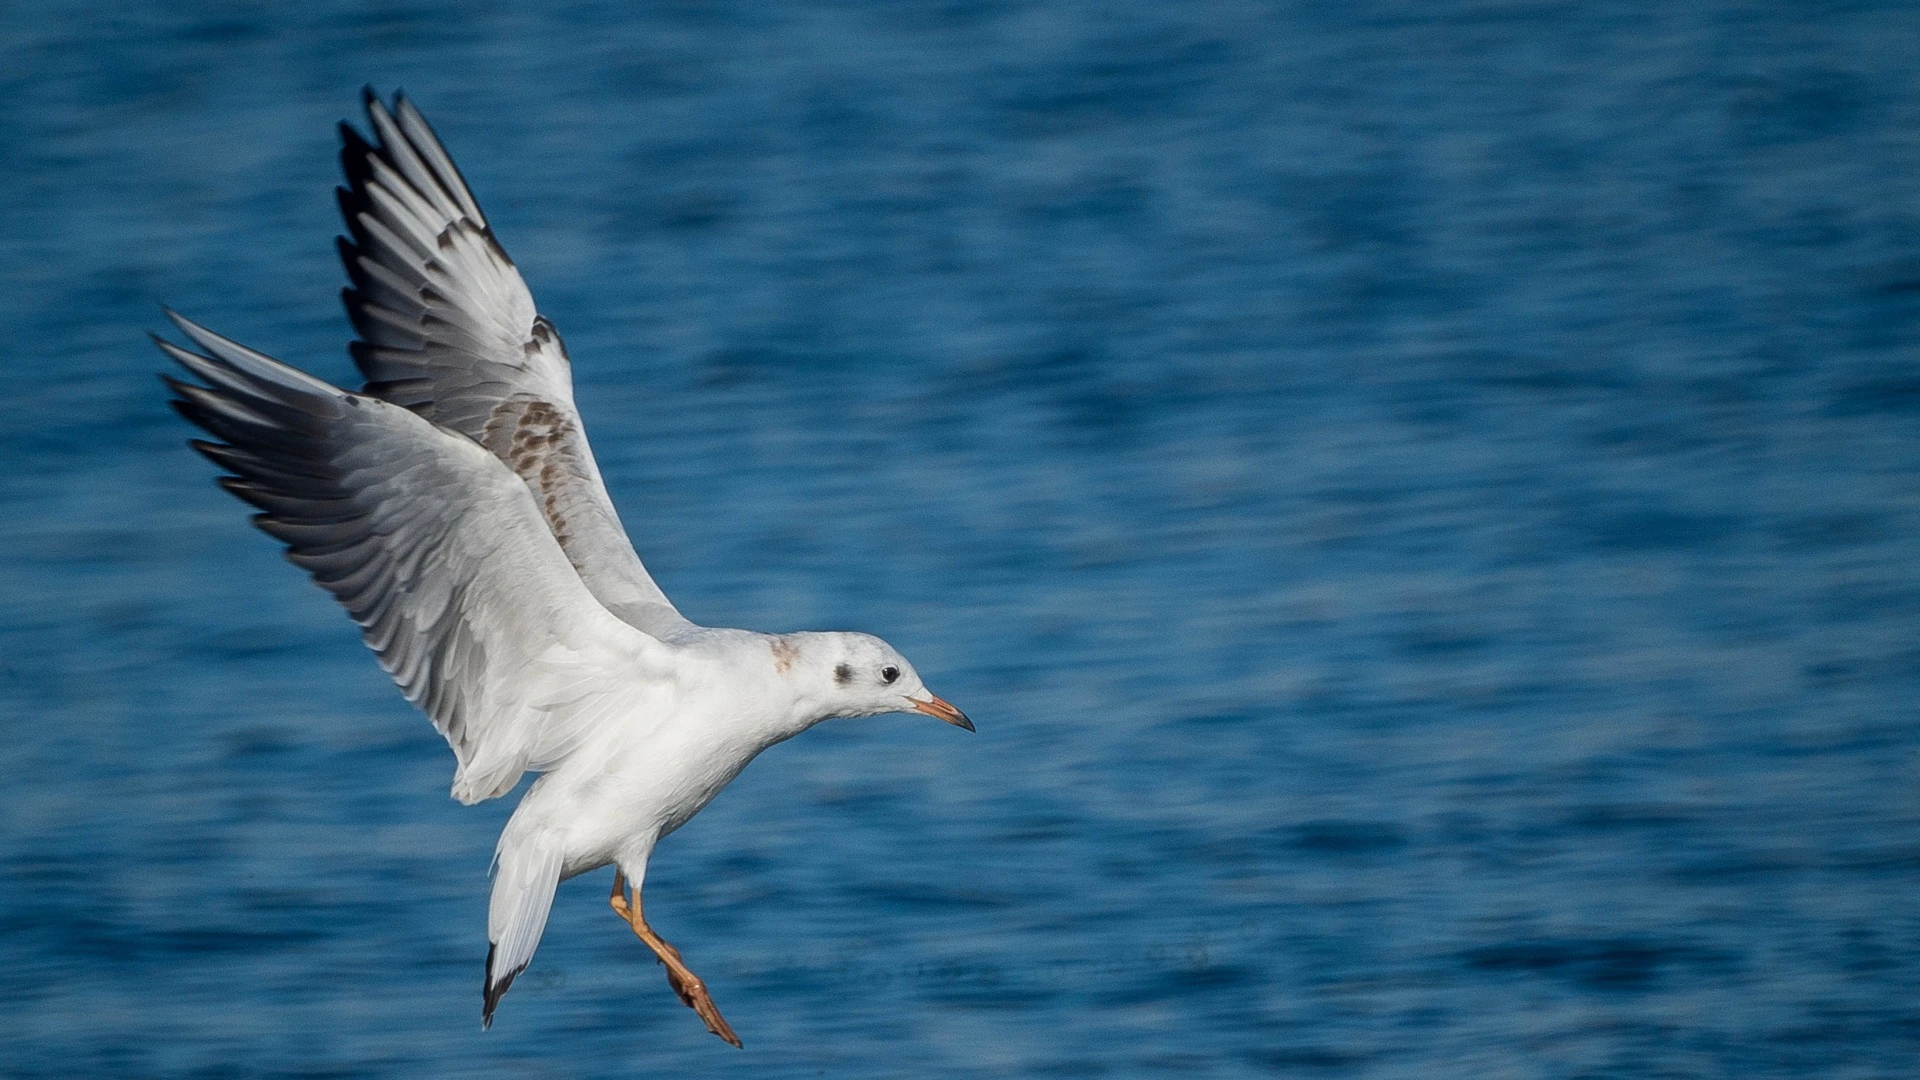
[0,0,1920,1076]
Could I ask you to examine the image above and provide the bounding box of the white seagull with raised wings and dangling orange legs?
[154,86,973,1047]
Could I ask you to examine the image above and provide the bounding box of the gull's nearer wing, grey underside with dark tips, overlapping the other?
[156,313,674,803]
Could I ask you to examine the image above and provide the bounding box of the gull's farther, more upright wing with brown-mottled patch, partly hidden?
[340,88,687,636]
